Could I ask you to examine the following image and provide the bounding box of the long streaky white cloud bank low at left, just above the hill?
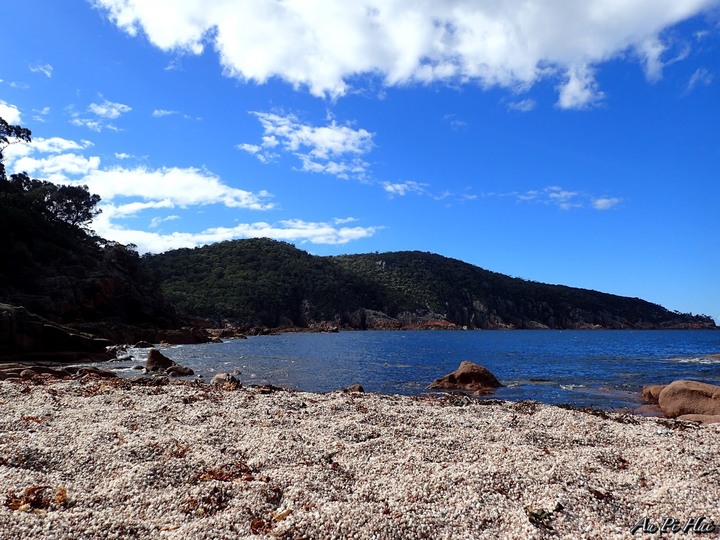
[5,130,380,252]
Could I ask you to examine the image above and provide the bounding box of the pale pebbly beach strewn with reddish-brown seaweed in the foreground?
[0,377,720,539]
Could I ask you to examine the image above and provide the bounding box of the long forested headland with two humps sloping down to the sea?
[142,239,715,329]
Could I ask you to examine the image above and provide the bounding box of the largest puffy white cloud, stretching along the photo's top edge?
[93,0,718,108]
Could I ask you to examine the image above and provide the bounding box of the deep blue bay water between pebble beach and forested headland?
[116,330,720,409]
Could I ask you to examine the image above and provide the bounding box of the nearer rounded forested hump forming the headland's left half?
[143,238,386,326]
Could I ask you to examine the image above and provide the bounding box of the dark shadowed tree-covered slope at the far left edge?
[0,119,176,327]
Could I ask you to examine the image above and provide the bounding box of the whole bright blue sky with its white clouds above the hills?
[0,0,720,320]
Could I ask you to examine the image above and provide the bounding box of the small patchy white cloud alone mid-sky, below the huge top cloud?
[237,112,373,178]
